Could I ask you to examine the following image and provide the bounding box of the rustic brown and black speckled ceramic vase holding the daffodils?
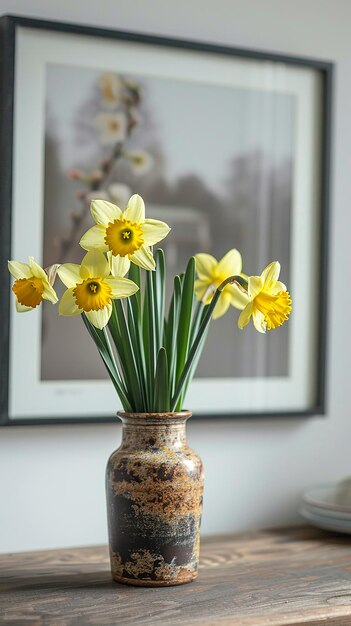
[106,411,203,587]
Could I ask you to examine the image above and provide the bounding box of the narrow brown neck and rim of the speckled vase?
[118,411,191,450]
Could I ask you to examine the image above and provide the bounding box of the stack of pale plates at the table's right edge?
[300,479,351,534]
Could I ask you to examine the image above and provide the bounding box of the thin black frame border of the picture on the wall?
[0,15,333,426]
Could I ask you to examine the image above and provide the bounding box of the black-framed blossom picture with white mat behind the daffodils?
[0,16,332,424]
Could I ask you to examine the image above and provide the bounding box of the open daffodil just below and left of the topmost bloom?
[57,250,139,329]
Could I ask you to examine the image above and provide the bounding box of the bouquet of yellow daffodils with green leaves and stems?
[8,195,291,413]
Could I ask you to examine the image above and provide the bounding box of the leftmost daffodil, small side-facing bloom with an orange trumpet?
[8,257,58,313]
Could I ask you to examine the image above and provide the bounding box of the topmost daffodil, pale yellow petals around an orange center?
[80,194,170,276]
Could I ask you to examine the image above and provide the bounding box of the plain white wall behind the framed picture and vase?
[0,0,351,552]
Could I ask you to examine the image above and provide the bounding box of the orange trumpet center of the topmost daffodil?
[105,214,144,256]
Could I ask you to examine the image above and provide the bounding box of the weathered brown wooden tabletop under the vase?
[0,527,351,626]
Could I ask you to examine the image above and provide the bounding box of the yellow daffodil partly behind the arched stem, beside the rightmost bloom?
[195,248,249,319]
